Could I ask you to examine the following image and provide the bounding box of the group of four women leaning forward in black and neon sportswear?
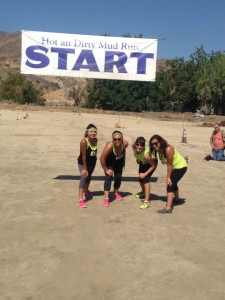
[78,124,187,214]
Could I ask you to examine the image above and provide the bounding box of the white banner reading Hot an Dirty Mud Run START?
[21,30,158,81]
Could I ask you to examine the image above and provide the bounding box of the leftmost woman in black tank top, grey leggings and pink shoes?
[77,124,98,208]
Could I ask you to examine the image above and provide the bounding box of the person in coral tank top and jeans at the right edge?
[210,122,225,161]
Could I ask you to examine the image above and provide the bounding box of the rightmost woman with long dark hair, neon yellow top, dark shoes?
[149,134,187,214]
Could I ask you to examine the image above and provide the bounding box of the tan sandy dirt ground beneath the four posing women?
[0,109,225,300]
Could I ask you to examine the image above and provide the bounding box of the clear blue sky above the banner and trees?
[0,0,225,59]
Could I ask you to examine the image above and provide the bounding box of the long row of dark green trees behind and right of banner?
[85,45,225,115]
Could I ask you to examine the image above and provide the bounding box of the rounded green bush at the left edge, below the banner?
[0,73,44,105]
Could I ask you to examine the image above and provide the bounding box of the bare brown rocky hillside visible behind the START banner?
[0,31,165,106]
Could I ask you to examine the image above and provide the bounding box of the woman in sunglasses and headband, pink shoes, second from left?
[100,130,128,207]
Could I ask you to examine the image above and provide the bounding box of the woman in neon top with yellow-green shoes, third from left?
[132,136,157,209]
